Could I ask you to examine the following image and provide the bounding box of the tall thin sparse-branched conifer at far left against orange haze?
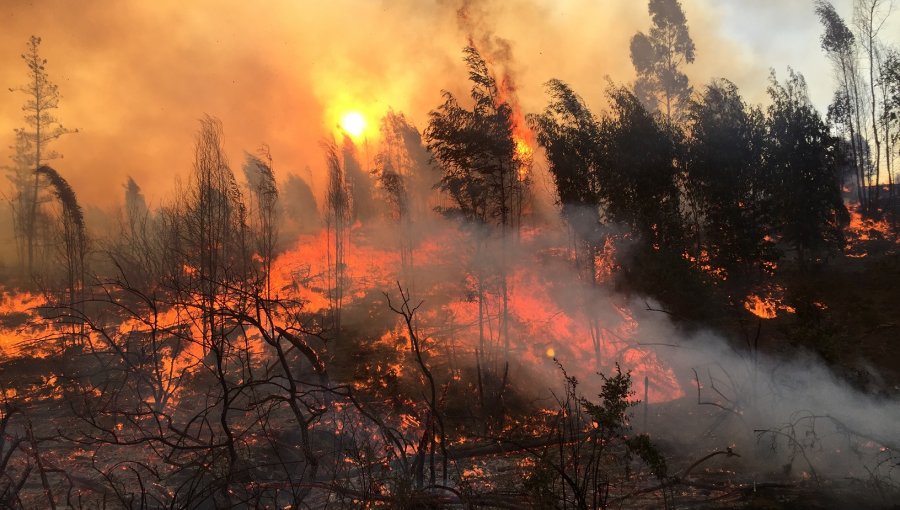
[10,36,73,273]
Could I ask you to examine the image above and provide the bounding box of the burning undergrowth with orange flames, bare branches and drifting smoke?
[4,190,900,506]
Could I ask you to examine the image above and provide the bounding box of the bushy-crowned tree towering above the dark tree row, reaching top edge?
[631,0,695,122]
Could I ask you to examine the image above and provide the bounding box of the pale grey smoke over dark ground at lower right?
[639,317,900,487]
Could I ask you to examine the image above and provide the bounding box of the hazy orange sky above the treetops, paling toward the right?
[0,0,900,211]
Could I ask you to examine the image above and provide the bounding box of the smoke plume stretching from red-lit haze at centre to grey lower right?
[266,166,900,490]
